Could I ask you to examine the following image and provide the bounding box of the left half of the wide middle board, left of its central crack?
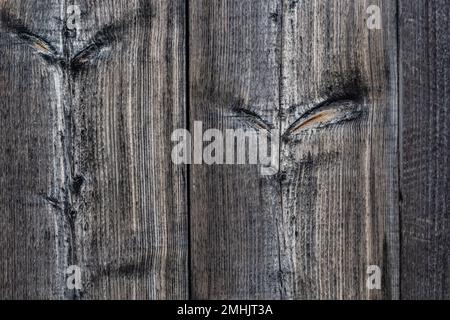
[189,0,281,299]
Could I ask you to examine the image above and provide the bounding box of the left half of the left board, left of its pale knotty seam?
[0,0,65,299]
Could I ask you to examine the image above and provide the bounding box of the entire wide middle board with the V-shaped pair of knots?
[189,1,399,299]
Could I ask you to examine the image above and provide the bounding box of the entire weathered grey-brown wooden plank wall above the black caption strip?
[0,0,450,299]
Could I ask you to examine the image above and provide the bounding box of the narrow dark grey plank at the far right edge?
[399,0,450,299]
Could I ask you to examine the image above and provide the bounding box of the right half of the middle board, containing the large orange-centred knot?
[279,0,399,299]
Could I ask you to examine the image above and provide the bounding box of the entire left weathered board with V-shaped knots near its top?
[0,0,188,299]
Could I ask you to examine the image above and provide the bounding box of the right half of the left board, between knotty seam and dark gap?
[68,0,188,299]
